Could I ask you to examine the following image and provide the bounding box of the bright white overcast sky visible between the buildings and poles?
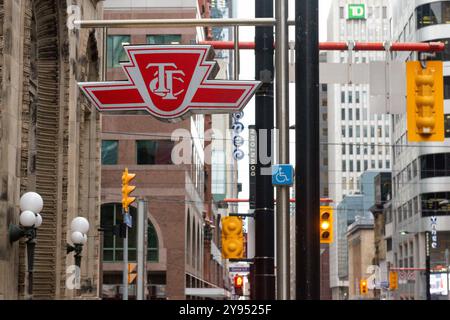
[236,0,332,213]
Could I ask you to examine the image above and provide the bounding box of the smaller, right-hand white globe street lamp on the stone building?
[67,217,89,292]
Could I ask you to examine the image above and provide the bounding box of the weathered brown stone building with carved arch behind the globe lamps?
[0,0,103,299]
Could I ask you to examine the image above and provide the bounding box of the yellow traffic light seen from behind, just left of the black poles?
[222,217,244,259]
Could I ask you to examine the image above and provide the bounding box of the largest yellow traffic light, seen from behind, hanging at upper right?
[406,61,445,142]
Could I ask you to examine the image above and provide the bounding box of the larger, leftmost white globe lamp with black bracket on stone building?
[9,192,44,299]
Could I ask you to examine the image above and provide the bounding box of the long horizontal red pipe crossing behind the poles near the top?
[199,41,445,52]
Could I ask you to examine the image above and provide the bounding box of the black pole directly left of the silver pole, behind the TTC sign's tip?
[254,0,275,300]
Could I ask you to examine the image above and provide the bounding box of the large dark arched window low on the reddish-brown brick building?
[100,203,159,262]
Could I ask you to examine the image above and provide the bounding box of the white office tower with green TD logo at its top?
[328,0,391,299]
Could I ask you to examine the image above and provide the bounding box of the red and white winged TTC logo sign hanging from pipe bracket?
[79,45,261,122]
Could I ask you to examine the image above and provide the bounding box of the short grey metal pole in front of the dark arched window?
[136,199,146,300]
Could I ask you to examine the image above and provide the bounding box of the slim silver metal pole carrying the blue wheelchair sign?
[275,0,291,300]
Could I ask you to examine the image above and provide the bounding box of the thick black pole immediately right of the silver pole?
[295,0,320,300]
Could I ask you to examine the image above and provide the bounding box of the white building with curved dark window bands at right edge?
[386,0,450,299]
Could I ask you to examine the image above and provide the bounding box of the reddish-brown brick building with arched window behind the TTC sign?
[102,0,237,299]
